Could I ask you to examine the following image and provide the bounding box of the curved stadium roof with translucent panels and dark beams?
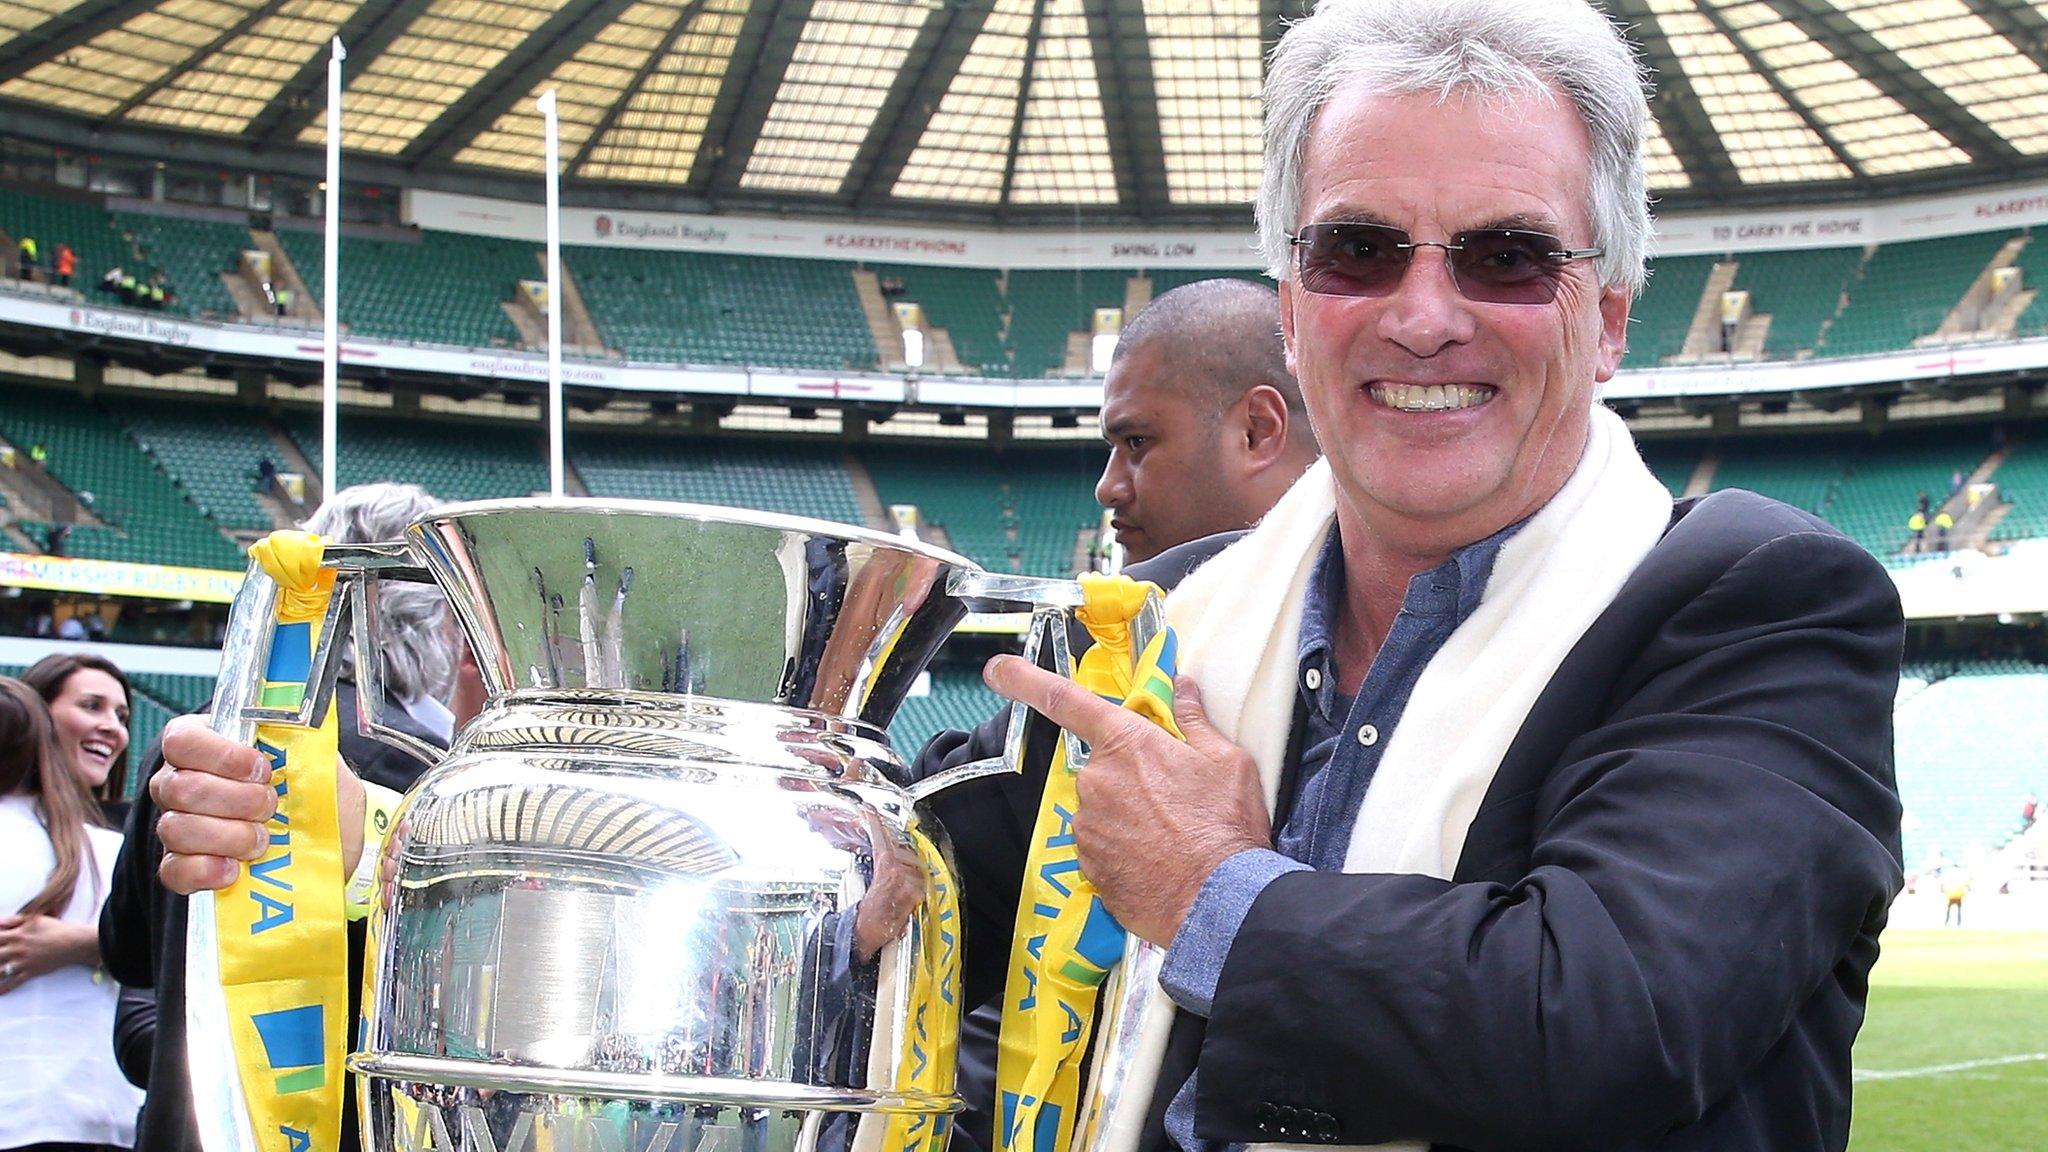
[0,0,2048,221]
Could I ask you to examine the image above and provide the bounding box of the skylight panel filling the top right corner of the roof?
[1829,0,2048,156]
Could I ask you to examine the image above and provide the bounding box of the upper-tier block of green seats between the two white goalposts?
[276,230,541,348]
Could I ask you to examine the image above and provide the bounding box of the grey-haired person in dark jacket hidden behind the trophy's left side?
[100,484,463,1152]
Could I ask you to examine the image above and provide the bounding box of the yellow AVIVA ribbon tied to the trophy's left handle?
[215,533,352,1152]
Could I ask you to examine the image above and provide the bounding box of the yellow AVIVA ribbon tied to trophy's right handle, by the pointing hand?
[995,574,1182,1152]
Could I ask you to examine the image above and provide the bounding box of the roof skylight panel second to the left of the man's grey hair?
[1010,0,1116,205]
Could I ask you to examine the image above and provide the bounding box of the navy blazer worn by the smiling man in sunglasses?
[920,490,1905,1152]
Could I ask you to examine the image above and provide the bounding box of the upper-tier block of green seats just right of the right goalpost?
[573,246,874,371]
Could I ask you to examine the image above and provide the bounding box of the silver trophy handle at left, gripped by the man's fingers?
[184,543,442,1152]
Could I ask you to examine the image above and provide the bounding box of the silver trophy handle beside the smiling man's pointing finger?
[909,570,1165,799]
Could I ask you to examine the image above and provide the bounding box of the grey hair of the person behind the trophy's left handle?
[305,484,457,701]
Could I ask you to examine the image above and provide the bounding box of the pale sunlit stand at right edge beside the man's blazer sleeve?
[1896,660,2048,869]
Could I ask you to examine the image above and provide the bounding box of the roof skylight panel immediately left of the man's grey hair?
[1145,0,1266,203]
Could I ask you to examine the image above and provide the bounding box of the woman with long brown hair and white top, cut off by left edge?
[0,676,141,1152]
